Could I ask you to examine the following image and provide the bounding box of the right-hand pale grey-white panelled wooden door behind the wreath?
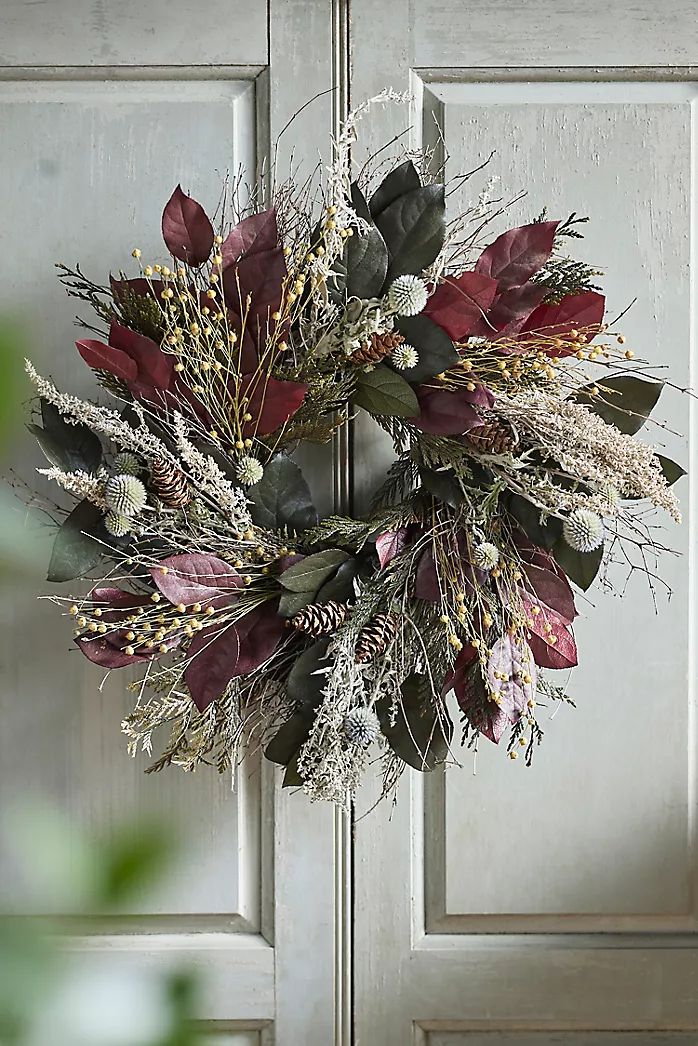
[352,0,698,1046]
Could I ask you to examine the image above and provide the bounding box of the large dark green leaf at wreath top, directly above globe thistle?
[376,185,446,283]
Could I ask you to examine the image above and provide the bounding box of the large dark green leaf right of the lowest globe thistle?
[376,673,453,771]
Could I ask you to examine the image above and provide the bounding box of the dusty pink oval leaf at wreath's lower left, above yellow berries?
[151,552,243,607]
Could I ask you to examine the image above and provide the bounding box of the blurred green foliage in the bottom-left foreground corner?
[0,808,200,1046]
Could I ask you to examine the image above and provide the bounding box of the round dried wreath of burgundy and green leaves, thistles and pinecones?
[27,96,683,803]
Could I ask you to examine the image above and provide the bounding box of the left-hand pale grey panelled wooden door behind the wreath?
[0,0,343,1046]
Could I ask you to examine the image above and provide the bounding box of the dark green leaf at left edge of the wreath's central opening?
[248,454,317,530]
